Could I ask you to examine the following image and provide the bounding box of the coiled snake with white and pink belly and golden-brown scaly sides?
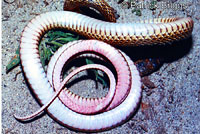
[14,0,193,132]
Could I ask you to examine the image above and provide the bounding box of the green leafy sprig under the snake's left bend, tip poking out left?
[6,30,79,73]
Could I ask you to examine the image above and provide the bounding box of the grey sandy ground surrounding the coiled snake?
[2,0,200,134]
